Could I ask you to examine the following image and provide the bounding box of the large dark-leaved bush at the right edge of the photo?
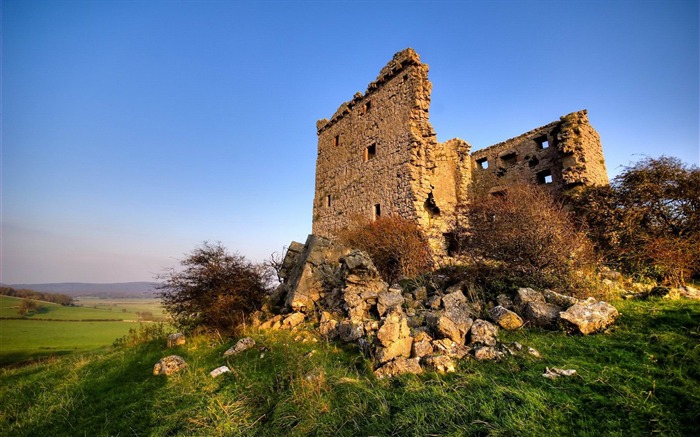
[573,157,700,285]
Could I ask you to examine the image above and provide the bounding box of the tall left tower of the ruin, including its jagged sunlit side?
[313,49,469,252]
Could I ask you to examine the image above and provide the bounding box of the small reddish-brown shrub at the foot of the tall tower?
[338,216,433,284]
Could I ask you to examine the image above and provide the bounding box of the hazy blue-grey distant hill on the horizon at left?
[8,282,158,297]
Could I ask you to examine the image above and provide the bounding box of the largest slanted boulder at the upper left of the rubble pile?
[280,235,350,312]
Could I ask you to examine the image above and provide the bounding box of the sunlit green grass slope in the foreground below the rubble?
[0,300,700,436]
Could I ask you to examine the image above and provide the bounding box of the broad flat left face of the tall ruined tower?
[313,49,434,238]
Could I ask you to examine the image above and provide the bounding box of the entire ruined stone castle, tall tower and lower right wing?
[312,48,608,254]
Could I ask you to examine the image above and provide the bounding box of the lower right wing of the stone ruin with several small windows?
[472,110,608,193]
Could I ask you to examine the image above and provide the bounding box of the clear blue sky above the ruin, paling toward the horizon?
[0,0,700,283]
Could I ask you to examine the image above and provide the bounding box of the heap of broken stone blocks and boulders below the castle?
[260,235,619,377]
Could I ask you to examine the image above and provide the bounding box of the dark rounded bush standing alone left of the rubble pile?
[157,242,270,330]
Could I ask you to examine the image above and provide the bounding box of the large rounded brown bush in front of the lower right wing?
[453,185,595,288]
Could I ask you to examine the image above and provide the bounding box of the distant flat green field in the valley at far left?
[0,296,170,366]
